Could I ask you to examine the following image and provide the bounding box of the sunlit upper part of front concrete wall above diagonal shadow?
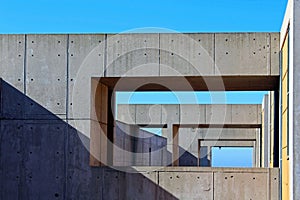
[0,33,279,119]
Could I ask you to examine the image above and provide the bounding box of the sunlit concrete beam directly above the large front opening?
[101,33,279,77]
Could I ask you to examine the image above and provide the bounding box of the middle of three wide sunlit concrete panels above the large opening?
[160,33,214,76]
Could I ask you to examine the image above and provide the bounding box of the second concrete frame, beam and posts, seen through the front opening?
[117,104,262,167]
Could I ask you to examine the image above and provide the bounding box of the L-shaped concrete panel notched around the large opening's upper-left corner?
[68,34,105,119]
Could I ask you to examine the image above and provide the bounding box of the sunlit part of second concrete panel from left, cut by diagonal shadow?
[26,35,67,118]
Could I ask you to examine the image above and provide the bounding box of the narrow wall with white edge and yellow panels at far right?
[280,0,300,200]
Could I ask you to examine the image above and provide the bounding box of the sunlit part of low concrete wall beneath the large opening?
[131,167,279,200]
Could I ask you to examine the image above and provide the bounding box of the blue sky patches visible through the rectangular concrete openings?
[116,91,268,167]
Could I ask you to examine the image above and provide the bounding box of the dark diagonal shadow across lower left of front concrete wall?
[0,79,176,199]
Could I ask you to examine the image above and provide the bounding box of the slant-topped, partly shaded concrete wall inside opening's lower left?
[113,122,170,166]
